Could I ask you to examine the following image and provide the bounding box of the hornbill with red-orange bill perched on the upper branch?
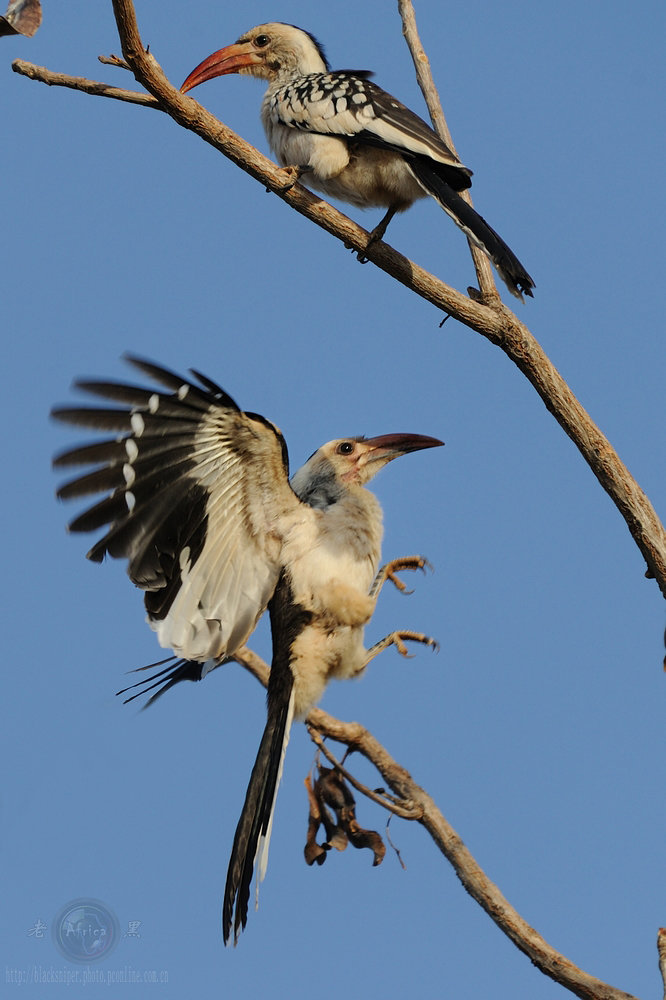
[181,23,534,299]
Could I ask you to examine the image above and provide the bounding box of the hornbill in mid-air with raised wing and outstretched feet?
[52,356,442,943]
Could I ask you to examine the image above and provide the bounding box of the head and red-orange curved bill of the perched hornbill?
[180,22,328,94]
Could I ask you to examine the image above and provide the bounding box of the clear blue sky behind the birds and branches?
[0,0,666,1000]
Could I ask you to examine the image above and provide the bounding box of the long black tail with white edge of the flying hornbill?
[222,671,293,944]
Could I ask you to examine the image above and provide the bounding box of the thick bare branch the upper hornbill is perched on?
[13,0,666,597]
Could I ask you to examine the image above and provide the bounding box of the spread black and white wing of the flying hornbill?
[53,357,301,661]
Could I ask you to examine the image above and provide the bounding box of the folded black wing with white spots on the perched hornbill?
[270,70,472,191]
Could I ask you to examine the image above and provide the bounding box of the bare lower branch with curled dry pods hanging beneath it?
[234,647,632,1000]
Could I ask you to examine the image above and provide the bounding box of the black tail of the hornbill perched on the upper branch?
[408,156,534,300]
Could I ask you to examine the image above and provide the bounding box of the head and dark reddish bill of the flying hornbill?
[291,434,444,507]
